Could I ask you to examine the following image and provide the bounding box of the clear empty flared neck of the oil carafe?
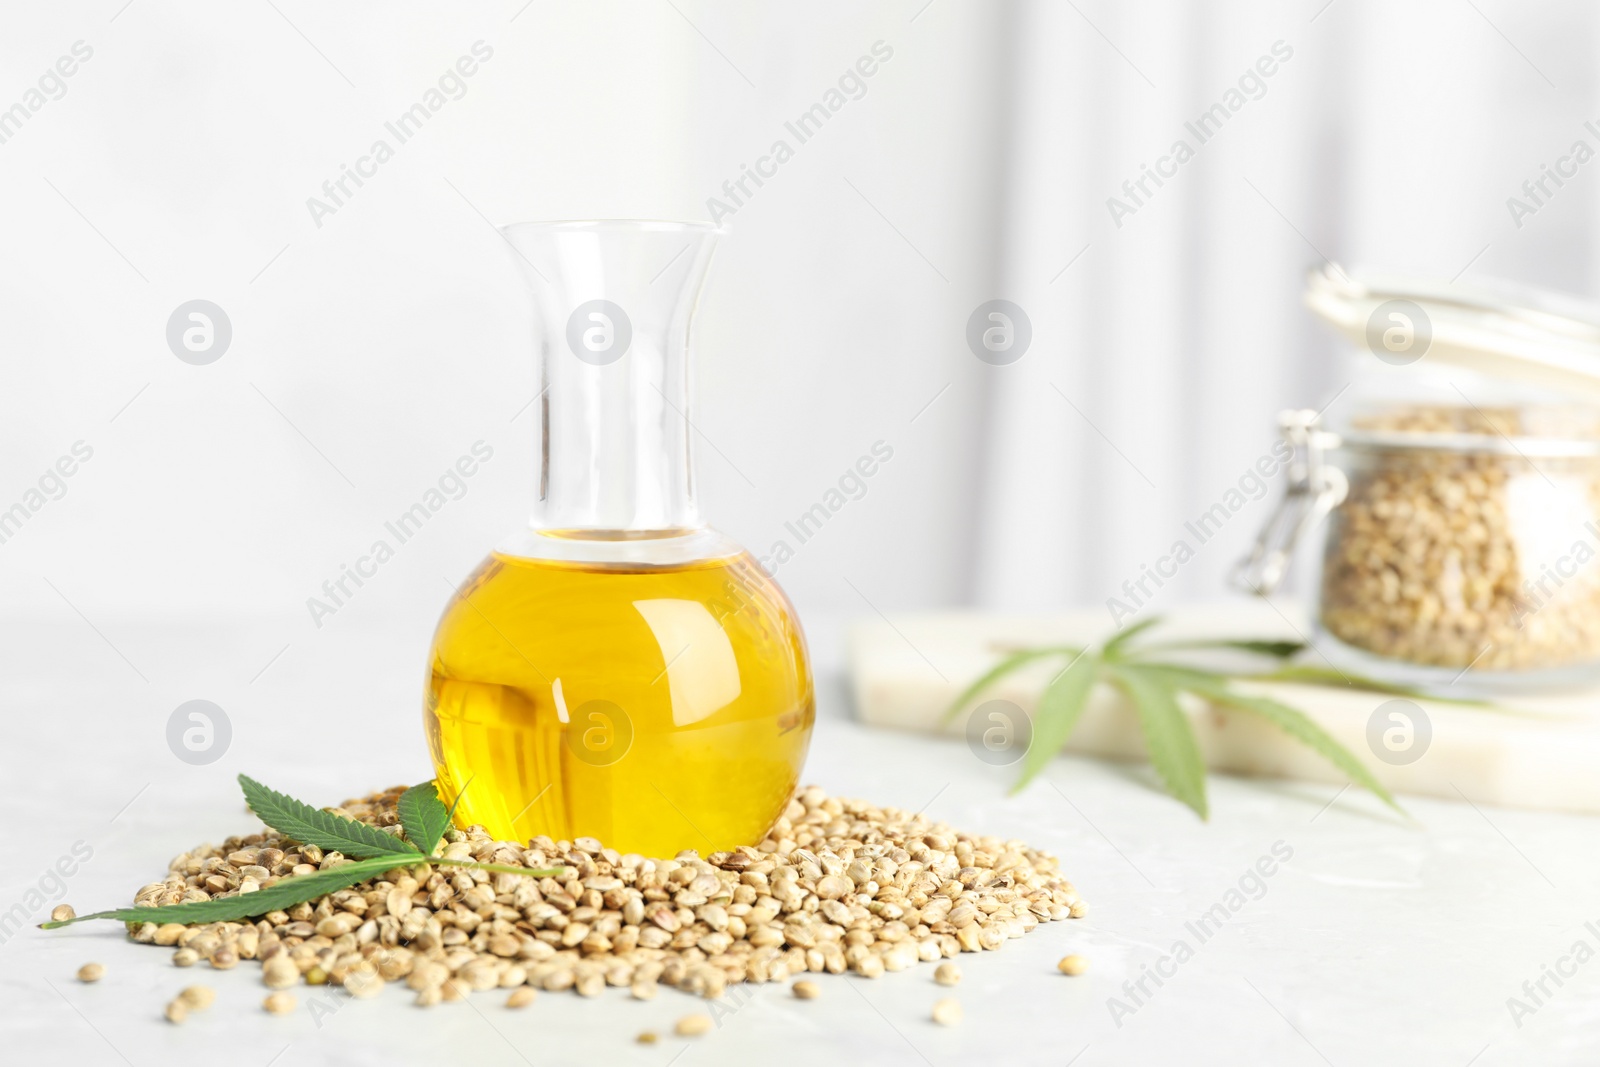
[506,222,715,541]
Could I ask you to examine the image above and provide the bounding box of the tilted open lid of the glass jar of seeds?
[1306,262,1600,405]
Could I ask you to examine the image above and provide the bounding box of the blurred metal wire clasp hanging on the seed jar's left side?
[1229,408,1350,597]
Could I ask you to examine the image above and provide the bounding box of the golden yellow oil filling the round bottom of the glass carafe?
[424,553,814,856]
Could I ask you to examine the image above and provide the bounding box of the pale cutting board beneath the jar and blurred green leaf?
[848,601,1600,813]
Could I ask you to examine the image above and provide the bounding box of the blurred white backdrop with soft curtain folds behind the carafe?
[0,0,1600,633]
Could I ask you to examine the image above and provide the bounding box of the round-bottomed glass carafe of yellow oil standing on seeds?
[424,221,814,856]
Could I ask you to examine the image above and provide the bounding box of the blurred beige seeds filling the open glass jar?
[1318,406,1600,672]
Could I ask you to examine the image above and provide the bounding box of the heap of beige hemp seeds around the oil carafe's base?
[128,787,1086,1011]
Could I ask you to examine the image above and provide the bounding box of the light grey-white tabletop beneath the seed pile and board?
[0,607,1600,1067]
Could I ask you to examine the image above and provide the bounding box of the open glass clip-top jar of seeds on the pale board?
[1235,267,1600,694]
